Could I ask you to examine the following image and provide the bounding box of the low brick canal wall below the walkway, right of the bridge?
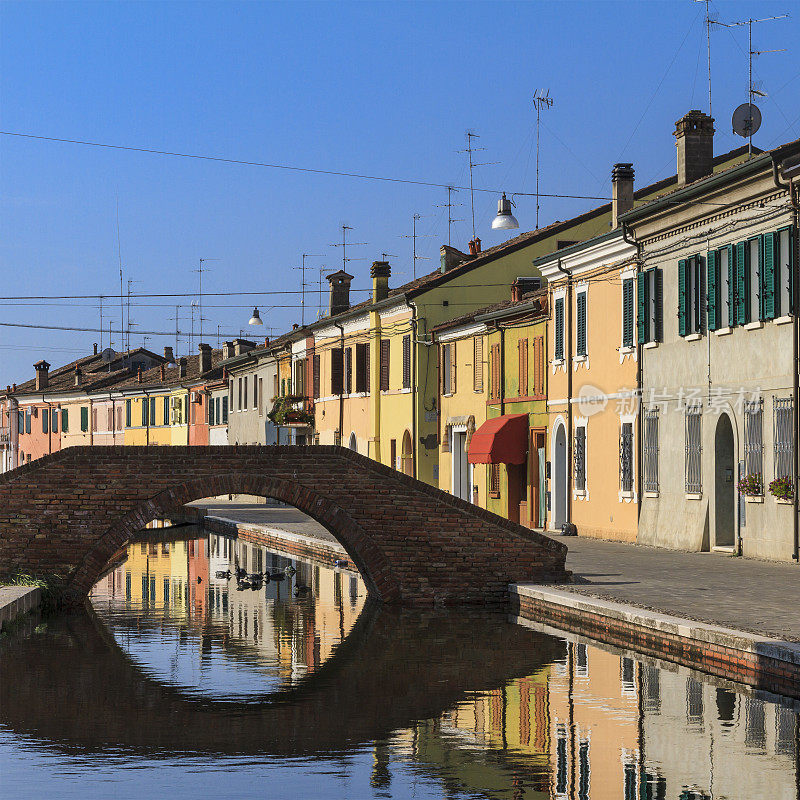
[511,591,800,698]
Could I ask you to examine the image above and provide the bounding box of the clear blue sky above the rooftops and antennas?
[0,0,800,385]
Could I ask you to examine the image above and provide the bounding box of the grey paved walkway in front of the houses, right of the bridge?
[558,537,800,642]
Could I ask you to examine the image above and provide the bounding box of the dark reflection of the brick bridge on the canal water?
[0,604,563,755]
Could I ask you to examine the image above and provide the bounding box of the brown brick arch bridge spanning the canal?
[0,446,568,605]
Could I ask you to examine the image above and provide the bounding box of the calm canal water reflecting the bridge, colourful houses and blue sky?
[0,528,800,800]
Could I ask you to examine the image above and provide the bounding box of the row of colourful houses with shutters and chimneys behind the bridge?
[0,111,800,560]
